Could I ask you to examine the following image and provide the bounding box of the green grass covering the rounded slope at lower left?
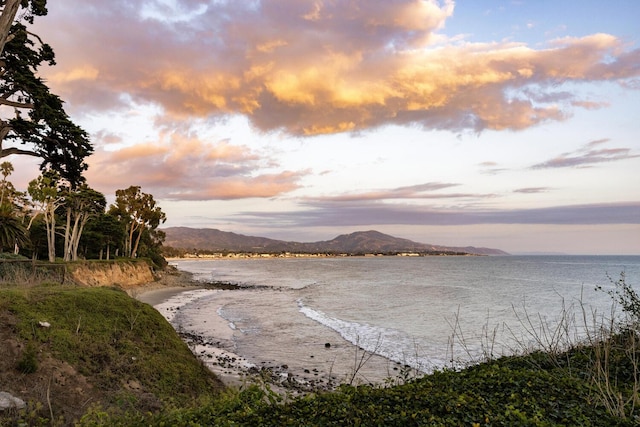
[0,284,223,424]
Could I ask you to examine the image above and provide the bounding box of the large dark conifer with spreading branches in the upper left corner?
[0,0,93,187]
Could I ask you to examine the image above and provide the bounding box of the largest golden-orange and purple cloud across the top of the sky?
[39,0,640,136]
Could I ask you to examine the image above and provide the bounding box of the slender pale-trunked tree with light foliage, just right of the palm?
[27,172,59,262]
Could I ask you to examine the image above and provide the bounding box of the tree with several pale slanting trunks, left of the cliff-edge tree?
[63,184,107,261]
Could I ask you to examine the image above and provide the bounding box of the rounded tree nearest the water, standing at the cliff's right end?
[109,185,167,258]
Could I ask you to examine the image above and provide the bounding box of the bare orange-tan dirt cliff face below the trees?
[70,262,155,289]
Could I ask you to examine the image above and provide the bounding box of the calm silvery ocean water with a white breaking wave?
[166,256,640,384]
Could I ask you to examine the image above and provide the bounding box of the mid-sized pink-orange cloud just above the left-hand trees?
[86,134,310,200]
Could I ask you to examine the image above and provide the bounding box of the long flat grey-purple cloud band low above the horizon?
[235,202,640,228]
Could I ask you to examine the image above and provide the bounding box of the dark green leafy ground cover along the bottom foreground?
[81,350,637,426]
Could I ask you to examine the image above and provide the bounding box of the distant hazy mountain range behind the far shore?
[162,227,508,255]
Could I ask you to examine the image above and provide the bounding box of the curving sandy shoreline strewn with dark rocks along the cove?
[132,269,421,394]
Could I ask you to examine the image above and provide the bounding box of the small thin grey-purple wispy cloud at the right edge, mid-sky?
[531,139,640,169]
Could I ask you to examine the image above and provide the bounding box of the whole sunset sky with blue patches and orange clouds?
[9,0,640,255]
